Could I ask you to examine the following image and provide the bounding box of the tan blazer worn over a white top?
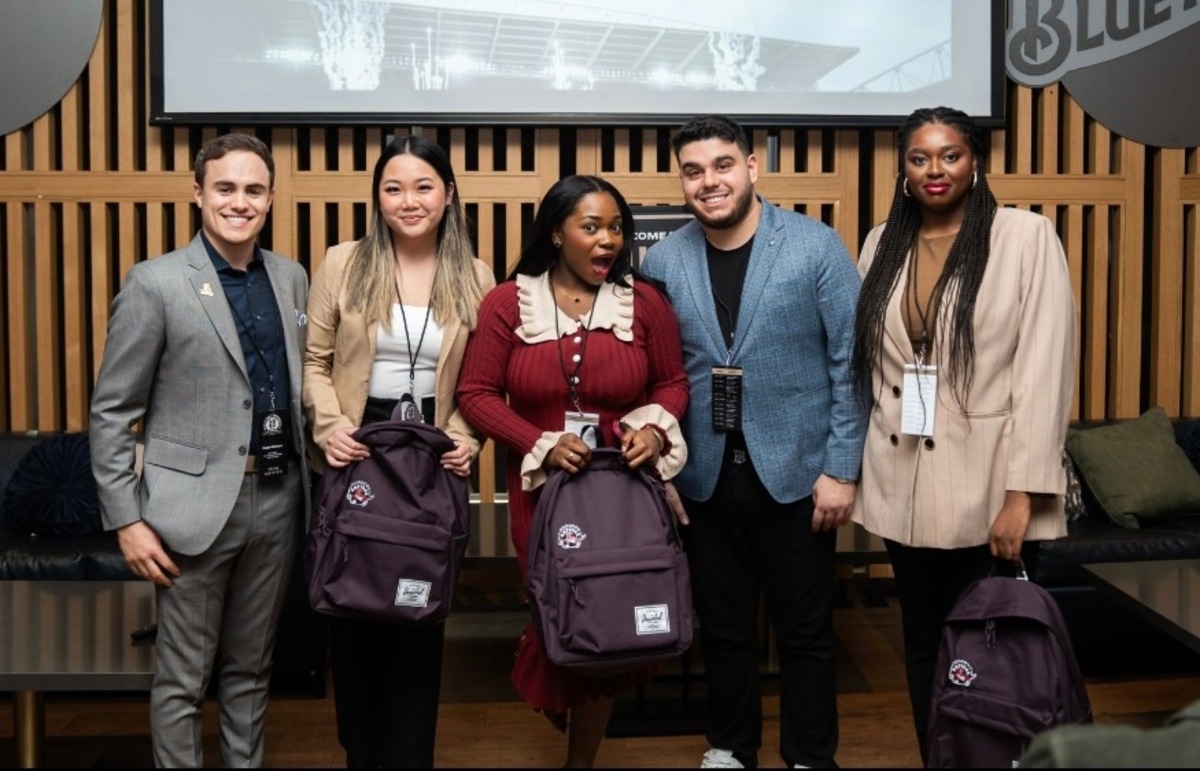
[304,241,496,471]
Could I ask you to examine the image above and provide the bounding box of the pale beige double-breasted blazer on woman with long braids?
[853,208,1078,549]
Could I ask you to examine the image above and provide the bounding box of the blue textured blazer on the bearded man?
[642,194,865,503]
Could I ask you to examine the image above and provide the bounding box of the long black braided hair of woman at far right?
[852,107,996,410]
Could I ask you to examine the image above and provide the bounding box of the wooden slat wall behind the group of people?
[0,0,1200,552]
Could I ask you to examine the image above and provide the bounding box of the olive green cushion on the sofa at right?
[1067,407,1200,528]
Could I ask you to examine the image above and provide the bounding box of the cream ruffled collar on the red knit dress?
[517,270,634,343]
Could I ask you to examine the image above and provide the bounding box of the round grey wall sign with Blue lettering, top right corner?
[1006,0,1200,148]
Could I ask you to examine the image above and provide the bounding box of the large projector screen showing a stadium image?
[150,0,1004,126]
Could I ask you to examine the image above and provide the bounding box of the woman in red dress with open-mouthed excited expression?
[457,175,688,767]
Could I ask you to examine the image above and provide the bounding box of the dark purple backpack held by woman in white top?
[305,416,470,623]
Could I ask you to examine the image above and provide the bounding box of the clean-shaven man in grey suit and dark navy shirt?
[90,133,308,767]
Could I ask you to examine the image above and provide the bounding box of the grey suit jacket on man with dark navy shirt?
[89,234,308,555]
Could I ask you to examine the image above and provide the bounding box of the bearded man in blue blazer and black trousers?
[642,115,865,767]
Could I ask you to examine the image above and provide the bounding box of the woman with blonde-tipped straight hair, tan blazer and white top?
[304,136,496,767]
